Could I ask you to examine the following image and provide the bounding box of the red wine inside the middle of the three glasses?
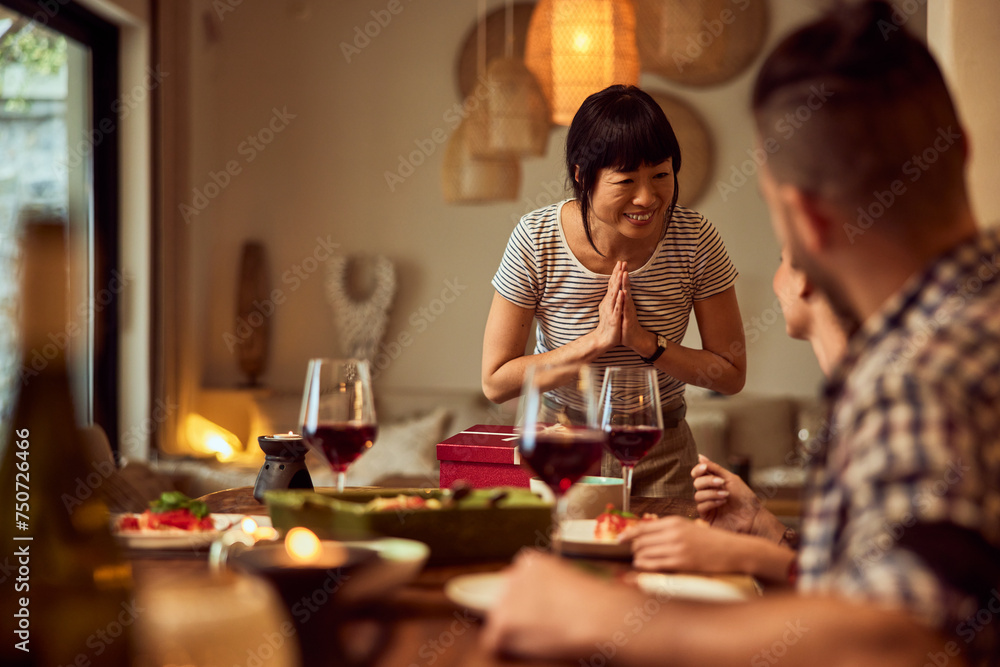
[519,430,606,496]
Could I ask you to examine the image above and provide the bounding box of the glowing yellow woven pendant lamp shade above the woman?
[524,0,639,125]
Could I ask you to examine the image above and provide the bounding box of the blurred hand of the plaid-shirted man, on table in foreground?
[482,551,643,658]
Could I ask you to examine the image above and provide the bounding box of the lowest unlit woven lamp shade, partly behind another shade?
[441,120,521,204]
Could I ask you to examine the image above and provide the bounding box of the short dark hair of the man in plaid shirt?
[752,0,966,227]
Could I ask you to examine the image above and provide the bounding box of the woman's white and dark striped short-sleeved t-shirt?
[493,200,737,405]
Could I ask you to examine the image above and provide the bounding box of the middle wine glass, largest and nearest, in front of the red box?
[516,365,607,553]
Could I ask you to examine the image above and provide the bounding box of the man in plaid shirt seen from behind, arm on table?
[484,1,1000,667]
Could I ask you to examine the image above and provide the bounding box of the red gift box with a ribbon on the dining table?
[437,424,534,489]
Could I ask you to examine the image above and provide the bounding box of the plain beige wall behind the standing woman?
[180,0,844,395]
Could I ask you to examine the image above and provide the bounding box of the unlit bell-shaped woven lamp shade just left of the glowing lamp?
[466,58,552,157]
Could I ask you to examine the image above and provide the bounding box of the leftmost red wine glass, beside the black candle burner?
[299,359,378,493]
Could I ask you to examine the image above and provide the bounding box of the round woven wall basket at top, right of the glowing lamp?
[634,0,769,86]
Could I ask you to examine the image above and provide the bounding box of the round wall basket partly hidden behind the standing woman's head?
[649,91,715,206]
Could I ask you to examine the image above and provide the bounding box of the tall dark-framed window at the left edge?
[0,0,121,447]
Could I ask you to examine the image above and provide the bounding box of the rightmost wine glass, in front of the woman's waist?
[600,366,663,512]
